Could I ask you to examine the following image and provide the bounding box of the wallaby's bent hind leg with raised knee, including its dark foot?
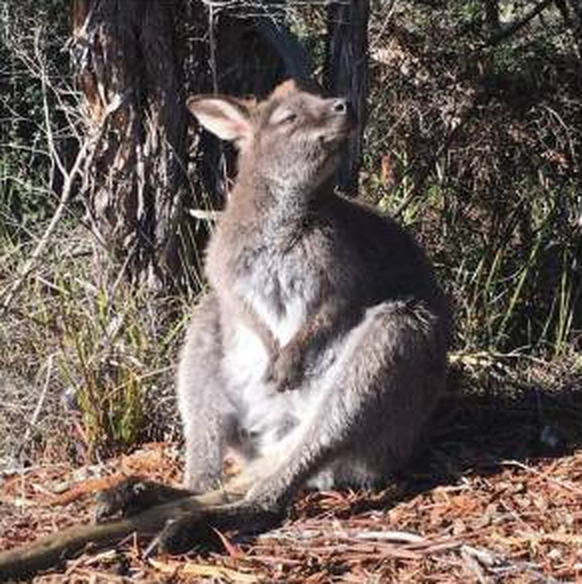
[161,301,448,550]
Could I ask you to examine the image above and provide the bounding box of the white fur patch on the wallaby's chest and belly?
[214,233,316,444]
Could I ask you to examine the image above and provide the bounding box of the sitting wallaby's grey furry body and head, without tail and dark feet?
[178,82,451,510]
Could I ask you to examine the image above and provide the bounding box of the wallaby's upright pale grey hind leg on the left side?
[177,294,229,493]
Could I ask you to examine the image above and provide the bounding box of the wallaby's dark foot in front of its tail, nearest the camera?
[157,503,284,554]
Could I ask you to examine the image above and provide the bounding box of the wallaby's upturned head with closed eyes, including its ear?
[188,81,354,192]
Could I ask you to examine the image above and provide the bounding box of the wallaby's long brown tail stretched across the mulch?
[0,489,240,582]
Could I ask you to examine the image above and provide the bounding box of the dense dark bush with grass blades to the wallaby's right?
[363,1,582,356]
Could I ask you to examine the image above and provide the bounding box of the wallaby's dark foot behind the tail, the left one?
[95,476,192,523]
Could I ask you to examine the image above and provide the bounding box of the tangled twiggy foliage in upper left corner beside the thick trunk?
[0,0,68,240]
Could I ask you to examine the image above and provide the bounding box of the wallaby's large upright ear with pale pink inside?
[186,95,252,142]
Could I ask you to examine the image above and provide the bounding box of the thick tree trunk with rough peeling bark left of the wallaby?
[73,0,195,287]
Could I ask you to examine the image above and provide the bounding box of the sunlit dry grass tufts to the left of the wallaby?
[0,226,188,471]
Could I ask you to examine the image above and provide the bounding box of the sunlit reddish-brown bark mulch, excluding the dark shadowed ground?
[0,444,582,583]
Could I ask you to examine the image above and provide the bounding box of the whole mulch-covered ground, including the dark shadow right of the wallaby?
[0,361,582,583]
